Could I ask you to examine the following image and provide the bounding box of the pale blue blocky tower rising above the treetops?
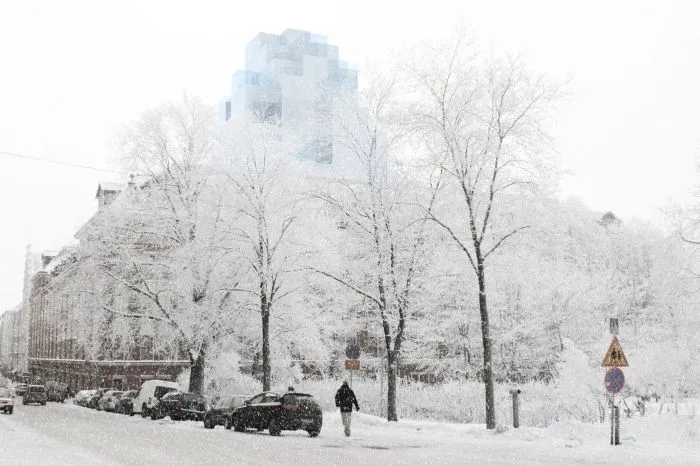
[219,29,372,179]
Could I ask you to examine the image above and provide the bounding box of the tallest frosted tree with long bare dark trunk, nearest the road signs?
[405,28,558,429]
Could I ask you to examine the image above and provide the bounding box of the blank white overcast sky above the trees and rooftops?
[0,0,700,313]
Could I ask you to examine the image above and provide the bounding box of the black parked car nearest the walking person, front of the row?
[230,392,323,437]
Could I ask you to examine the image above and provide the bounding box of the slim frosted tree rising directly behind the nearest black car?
[216,117,304,390]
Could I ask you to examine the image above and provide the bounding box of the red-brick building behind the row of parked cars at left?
[20,184,189,390]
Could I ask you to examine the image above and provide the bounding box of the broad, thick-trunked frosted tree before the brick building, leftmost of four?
[83,97,237,393]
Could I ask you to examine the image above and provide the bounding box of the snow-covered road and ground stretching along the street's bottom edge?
[0,403,700,466]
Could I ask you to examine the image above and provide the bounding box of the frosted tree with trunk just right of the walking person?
[314,76,432,421]
